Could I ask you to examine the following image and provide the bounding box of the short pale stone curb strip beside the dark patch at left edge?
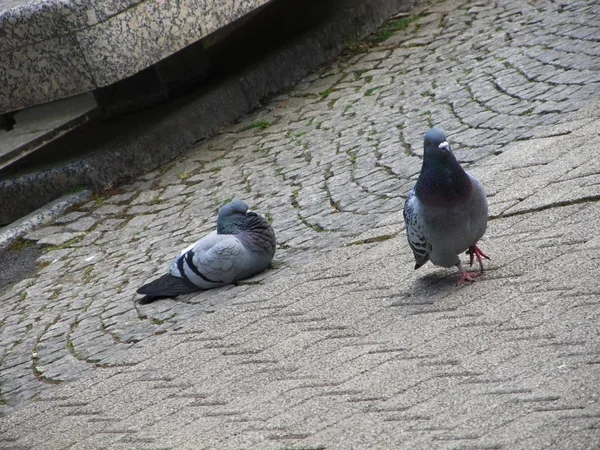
[0,190,92,250]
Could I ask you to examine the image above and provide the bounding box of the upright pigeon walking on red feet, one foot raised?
[404,128,490,285]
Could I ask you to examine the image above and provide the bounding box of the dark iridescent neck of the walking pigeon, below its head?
[415,157,472,206]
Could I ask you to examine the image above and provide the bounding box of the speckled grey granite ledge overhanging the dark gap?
[0,0,270,113]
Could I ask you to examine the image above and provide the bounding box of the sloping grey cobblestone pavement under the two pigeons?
[0,0,600,449]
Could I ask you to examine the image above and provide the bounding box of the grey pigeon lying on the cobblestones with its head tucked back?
[137,200,276,303]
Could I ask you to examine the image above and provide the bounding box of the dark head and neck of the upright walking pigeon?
[415,128,472,206]
